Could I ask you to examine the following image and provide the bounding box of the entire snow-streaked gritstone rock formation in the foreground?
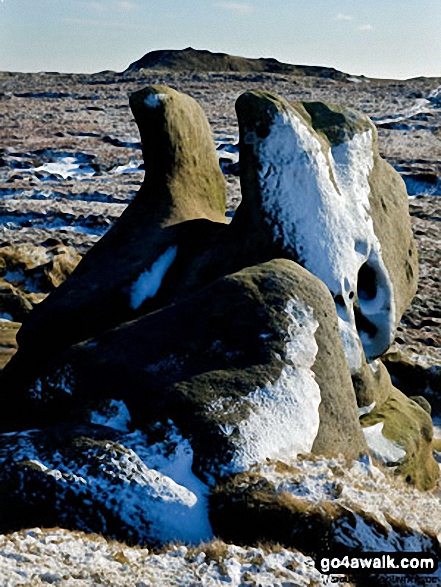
[0,86,438,550]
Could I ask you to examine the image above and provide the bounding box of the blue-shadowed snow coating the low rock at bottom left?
[0,423,213,544]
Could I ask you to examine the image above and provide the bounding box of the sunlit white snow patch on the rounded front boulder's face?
[212,299,321,473]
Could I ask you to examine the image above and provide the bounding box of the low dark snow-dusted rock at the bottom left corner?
[0,425,212,544]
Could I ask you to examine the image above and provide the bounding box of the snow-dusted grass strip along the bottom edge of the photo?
[0,528,344,587]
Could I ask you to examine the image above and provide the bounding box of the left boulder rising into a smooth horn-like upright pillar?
[6,86,225,386]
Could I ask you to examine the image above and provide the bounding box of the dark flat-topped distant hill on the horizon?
[126,47,348,80]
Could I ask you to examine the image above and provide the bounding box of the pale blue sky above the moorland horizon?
[0,0,441,78]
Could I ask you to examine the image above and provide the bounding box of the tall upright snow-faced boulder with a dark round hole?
[232,92,417,372]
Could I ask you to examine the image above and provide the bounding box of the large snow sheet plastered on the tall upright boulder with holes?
[256,110,395,365]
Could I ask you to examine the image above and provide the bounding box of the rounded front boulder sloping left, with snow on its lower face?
[3,260,367,479]
